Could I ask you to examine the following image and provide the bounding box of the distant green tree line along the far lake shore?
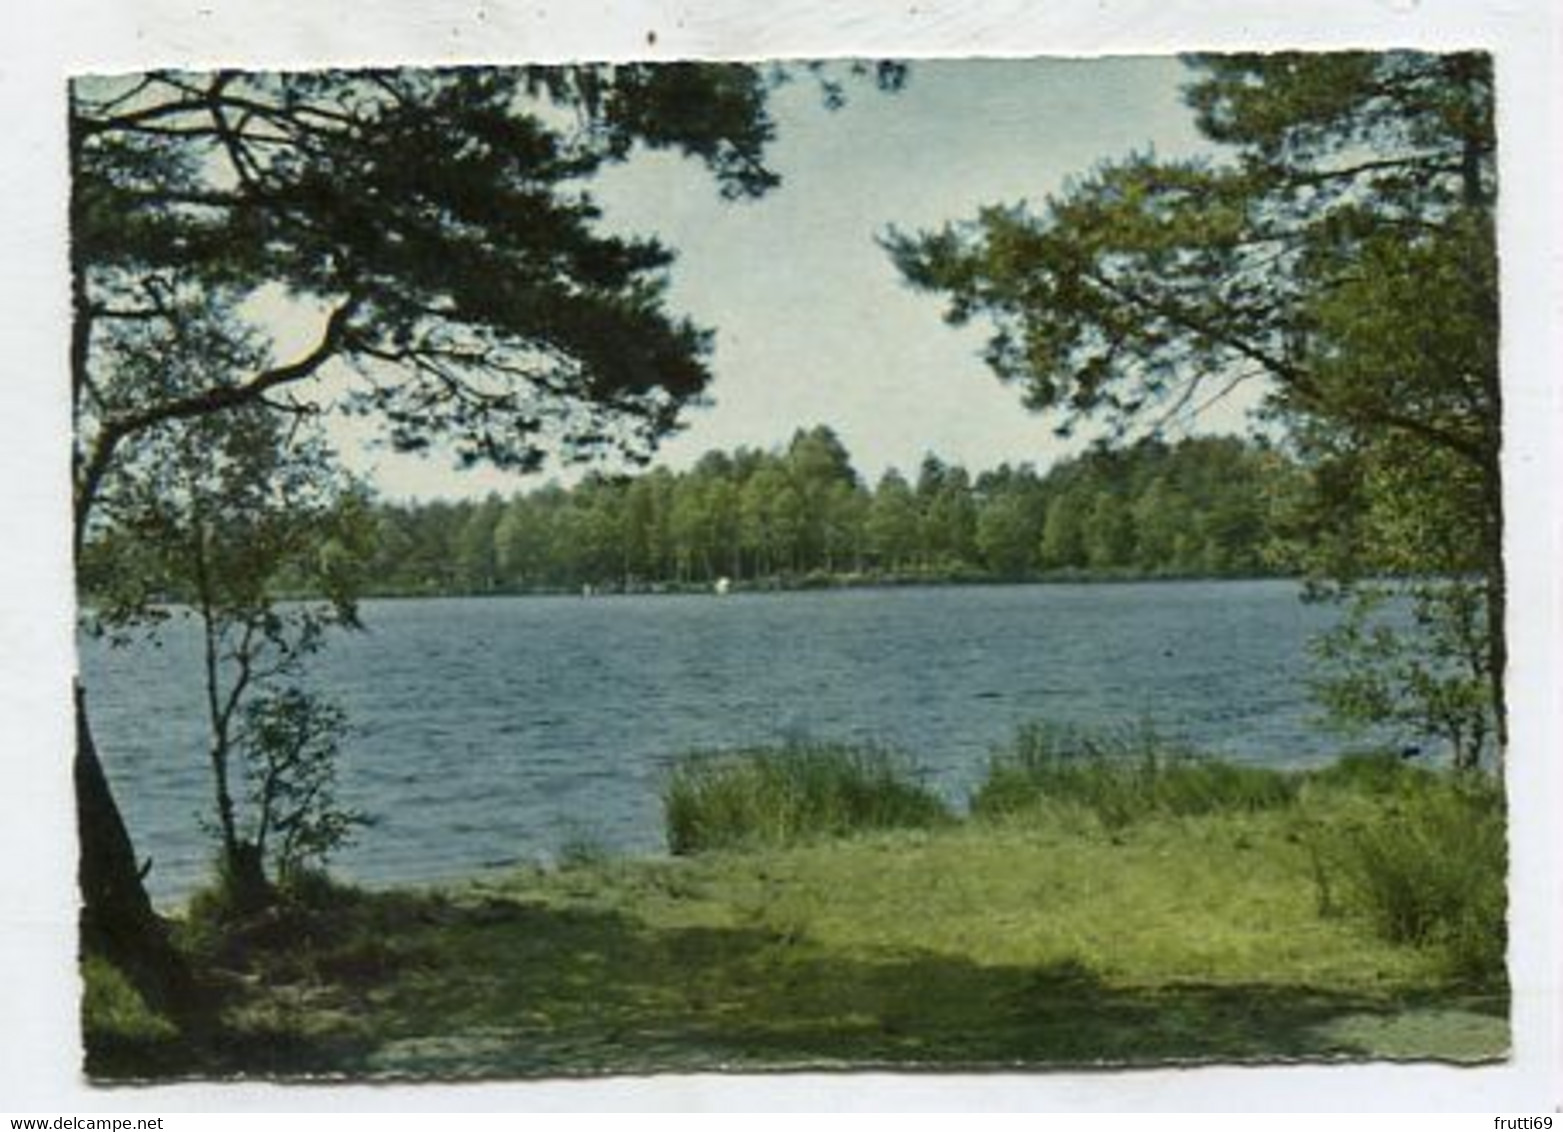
[354,425,1304,594]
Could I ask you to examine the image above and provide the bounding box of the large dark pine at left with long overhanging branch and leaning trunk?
[69,64,899,998]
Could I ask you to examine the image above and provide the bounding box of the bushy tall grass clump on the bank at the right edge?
[1325,774,1508,983]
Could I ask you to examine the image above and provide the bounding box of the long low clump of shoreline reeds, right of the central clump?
[971,724,1297,829]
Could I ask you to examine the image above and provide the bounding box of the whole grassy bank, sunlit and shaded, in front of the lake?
[92,730,1507,1077]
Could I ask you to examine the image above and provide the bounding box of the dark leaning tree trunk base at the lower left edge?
[75,685,192,1018]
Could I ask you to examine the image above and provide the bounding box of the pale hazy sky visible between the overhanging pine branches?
[348,55,1243,499]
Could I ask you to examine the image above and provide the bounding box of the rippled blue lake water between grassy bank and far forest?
[81,582,1336,901]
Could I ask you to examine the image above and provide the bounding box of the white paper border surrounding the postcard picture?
[0,0,1563,1113]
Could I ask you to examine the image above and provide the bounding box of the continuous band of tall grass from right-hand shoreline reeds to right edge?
[971,724,1507,987]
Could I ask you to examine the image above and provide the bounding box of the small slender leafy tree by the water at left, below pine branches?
[83,408,374,910]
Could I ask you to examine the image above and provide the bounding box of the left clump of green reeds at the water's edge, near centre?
[663,743,952,854]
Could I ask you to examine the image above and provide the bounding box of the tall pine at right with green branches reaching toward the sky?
[885,52,1507,765]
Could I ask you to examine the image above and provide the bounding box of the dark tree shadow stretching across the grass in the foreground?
[89,894,1507,1079]
